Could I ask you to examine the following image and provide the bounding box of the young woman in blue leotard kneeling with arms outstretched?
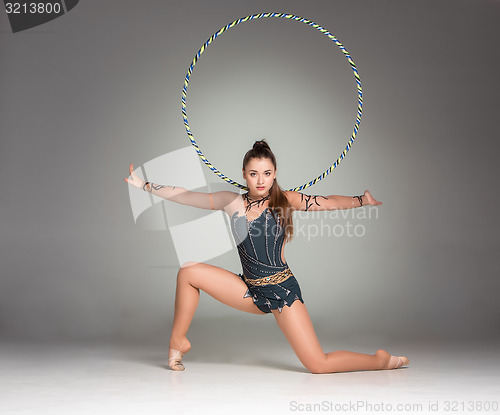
[125,140,409,373]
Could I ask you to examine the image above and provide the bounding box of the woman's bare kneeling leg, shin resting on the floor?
[273,300,391,373]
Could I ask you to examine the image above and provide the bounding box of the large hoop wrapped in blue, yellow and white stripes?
[182,13,363,191]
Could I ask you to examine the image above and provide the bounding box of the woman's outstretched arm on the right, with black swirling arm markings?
[285,190,382,211]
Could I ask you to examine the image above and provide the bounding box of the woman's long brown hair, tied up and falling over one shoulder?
[243,140,293,243]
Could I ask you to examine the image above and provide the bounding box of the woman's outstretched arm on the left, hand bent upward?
[125,163,239,210]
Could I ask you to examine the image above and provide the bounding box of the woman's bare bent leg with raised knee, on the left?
[169,263,266,353]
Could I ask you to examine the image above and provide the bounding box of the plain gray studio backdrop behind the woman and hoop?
[0,0,500,347]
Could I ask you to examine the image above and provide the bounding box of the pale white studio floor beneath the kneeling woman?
[0,338,500,415]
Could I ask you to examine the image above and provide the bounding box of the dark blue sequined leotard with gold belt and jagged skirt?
[231,197,304,313]
